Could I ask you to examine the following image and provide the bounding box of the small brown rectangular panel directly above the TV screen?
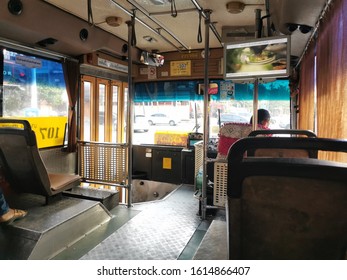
[222,25,255,43]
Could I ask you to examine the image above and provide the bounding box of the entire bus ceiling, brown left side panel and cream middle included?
[0,0,331,65]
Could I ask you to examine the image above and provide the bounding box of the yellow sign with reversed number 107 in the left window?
[0,117,67,148]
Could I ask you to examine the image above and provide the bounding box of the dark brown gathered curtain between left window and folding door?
[63,59,80,152]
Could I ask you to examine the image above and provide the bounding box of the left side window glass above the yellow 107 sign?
[3,50,68,117]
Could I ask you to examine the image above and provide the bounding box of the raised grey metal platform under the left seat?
[0,197,112,260]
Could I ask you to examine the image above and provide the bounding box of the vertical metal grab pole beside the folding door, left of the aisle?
[126,18,135,207]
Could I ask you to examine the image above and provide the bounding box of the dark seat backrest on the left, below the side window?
[0,119,79,197]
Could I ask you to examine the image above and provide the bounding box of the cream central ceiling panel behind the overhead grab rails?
[46,0,265,52]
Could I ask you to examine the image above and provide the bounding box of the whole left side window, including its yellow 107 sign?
[0,49,68,148]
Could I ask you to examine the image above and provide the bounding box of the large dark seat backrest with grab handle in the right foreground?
[227,137,347,260]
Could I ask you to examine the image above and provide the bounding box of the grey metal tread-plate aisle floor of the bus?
[53,185,226,260]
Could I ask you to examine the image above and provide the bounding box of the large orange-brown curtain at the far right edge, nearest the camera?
[317,0,347,161]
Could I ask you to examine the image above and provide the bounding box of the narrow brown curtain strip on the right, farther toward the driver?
[298,41,315,131]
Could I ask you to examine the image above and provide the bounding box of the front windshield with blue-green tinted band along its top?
[133,80,290,146]
